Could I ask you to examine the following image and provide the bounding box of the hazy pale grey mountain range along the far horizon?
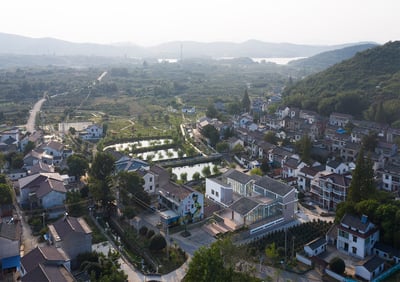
[0,33,378,58]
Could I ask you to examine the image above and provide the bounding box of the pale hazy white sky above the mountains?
[0,0,400,45]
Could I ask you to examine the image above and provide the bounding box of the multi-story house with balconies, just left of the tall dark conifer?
[310,171,351,210]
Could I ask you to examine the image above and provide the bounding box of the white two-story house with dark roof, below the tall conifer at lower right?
[336,214,379,259]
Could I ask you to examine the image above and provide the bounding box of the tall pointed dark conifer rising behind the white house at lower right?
[347,147,376,204]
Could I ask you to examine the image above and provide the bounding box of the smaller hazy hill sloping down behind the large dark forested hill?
[288,43,378,73]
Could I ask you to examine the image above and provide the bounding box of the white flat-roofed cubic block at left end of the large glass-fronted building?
[206,178,233,207]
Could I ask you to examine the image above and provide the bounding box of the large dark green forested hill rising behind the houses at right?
[283,41,400,124]
